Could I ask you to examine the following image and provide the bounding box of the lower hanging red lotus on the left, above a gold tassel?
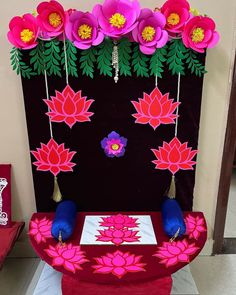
[31,138,76,176]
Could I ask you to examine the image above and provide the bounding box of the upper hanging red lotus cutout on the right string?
[131,87,180,130]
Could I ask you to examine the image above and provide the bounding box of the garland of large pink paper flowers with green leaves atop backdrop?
[8,0,219,79]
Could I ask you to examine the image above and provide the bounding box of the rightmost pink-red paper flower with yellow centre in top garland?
[182,16,220,53]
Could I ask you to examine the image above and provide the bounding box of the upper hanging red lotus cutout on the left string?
[44,85,94,128]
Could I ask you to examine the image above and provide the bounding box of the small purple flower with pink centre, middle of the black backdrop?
[101,131,127,158]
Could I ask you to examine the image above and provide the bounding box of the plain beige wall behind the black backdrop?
[0,0,236,256]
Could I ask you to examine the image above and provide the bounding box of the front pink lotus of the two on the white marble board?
[96,228,140,246]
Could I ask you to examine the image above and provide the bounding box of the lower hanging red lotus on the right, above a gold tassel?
[152,137,198,174]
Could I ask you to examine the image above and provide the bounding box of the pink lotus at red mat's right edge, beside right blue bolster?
[185,214,206,240]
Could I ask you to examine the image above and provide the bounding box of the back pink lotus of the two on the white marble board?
[100,214,138,229]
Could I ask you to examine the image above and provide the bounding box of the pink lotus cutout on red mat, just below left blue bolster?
[45,244,89,273]
